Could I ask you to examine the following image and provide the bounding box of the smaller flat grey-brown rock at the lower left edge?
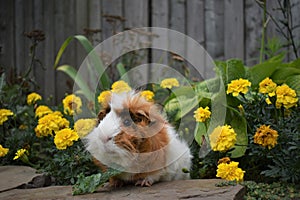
[0,165,40,192]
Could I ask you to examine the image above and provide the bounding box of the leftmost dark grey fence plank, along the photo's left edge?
[0,1,15,72]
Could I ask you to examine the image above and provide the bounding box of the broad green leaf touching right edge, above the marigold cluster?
[271,67,300,84]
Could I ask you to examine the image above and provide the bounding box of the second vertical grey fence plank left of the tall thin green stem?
[224,0,244,60]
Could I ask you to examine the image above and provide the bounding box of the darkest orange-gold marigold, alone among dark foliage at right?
[254,125,278,149]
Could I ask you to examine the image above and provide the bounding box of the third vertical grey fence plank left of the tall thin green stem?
[205,0,224,60]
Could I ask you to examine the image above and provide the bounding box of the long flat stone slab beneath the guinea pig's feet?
[0,179,245,200]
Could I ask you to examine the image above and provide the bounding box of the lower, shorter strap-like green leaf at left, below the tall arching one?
[57,65,94,101]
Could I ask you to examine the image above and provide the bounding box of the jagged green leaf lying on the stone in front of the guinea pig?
[72,168,121,195]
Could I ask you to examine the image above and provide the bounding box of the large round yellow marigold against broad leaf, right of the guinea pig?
[209,125,236,151]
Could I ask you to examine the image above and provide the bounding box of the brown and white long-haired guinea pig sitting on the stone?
[84,91,192,186]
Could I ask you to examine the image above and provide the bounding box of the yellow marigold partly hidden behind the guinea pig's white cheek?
[74,119,97,138]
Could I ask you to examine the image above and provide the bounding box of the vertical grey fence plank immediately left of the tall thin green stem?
[245,0,262,66]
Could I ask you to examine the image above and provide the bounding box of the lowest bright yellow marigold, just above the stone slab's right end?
[216,161,245,182]
